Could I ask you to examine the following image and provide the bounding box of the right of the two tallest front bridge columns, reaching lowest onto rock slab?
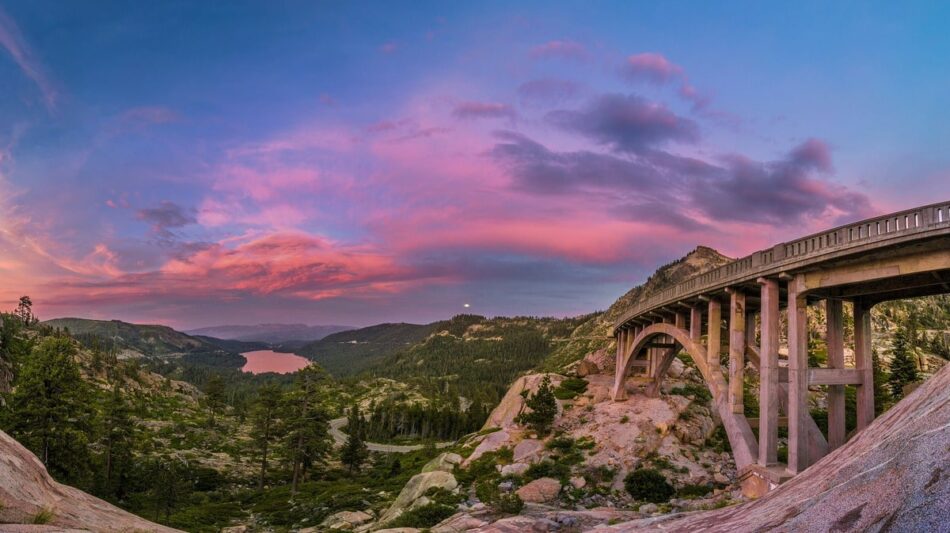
[788,275,809,475]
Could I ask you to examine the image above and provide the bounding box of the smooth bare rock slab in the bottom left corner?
[0,431,177,532]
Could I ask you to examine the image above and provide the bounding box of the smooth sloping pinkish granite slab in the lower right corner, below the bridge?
[597,360,950,533]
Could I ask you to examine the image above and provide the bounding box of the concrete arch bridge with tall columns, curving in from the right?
[612,201,950,496]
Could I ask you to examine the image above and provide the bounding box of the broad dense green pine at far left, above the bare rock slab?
[9,337,92,485]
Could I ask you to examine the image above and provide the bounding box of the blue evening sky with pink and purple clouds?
[0,0,950,328]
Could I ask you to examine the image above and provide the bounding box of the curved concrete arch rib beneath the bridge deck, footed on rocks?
[613,323,757,470]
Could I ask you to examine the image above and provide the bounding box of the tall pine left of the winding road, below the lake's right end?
[284,364,331,494]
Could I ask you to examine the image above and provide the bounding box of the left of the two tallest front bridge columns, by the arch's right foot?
[758,278,780,466]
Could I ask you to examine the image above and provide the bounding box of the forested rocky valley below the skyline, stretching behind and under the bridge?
[0,244,950,532]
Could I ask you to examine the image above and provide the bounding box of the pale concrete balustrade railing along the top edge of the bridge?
[614,201,950,329]
